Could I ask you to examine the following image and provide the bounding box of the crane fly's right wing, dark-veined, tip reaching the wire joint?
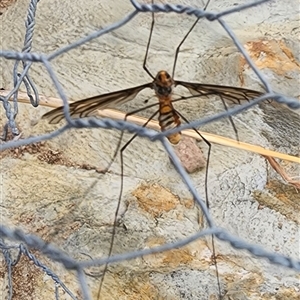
[175,81,263,104]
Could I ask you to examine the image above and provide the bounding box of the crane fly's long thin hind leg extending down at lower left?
[97,109,159,300]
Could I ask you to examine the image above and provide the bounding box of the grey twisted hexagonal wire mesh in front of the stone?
[0,0,300,299]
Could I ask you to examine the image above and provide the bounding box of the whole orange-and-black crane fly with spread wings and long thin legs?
[43,1,262,299]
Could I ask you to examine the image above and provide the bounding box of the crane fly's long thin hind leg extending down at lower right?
[176,110,221,299]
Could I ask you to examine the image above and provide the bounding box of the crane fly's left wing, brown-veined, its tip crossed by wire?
[42,83,152,124]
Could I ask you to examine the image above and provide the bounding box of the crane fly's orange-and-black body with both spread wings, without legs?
[43,70,262,144]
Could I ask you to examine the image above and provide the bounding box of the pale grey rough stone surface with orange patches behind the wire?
[0,0,300,299]
